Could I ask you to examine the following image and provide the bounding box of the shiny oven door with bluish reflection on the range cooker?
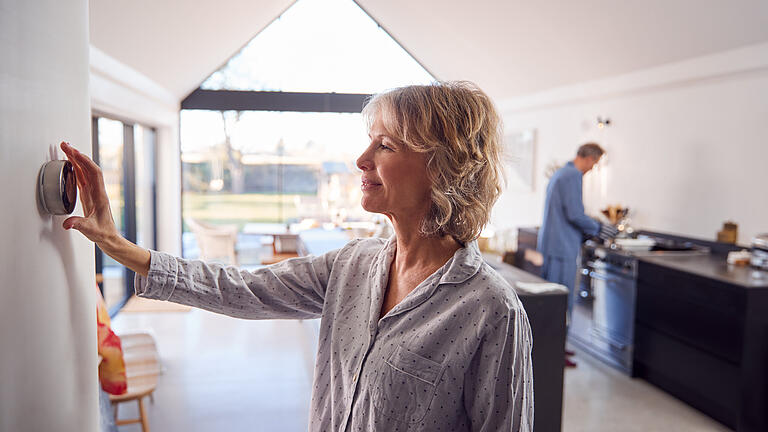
[590,266,636,372]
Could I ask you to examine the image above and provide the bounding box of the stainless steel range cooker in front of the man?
[568,238,709,375]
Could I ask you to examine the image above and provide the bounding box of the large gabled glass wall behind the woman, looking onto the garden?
[181,0,434,265]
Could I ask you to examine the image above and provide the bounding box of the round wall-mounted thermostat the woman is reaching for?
[38,160,77,215]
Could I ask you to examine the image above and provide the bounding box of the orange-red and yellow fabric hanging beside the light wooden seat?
[96,287,128,395]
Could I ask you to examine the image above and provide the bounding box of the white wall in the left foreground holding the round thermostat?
[0,0,98,432]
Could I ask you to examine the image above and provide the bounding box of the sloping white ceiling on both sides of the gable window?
[90,0,768,101]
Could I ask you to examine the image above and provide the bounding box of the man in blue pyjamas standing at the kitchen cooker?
[537,143,618,367]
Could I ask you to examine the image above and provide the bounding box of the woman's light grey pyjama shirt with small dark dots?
[135,237,533,432]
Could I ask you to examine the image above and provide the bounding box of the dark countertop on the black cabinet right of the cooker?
[638,254,768,289]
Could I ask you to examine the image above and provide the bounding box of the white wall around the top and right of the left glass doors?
[90,46,181,255]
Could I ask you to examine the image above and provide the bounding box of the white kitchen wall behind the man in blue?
[493,44,768,243]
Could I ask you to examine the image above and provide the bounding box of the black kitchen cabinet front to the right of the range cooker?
[633,257,768,432]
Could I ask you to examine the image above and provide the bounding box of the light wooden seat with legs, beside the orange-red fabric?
[109,332,161,432]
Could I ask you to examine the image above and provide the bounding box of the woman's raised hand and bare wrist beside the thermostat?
[61,142,150,276]
